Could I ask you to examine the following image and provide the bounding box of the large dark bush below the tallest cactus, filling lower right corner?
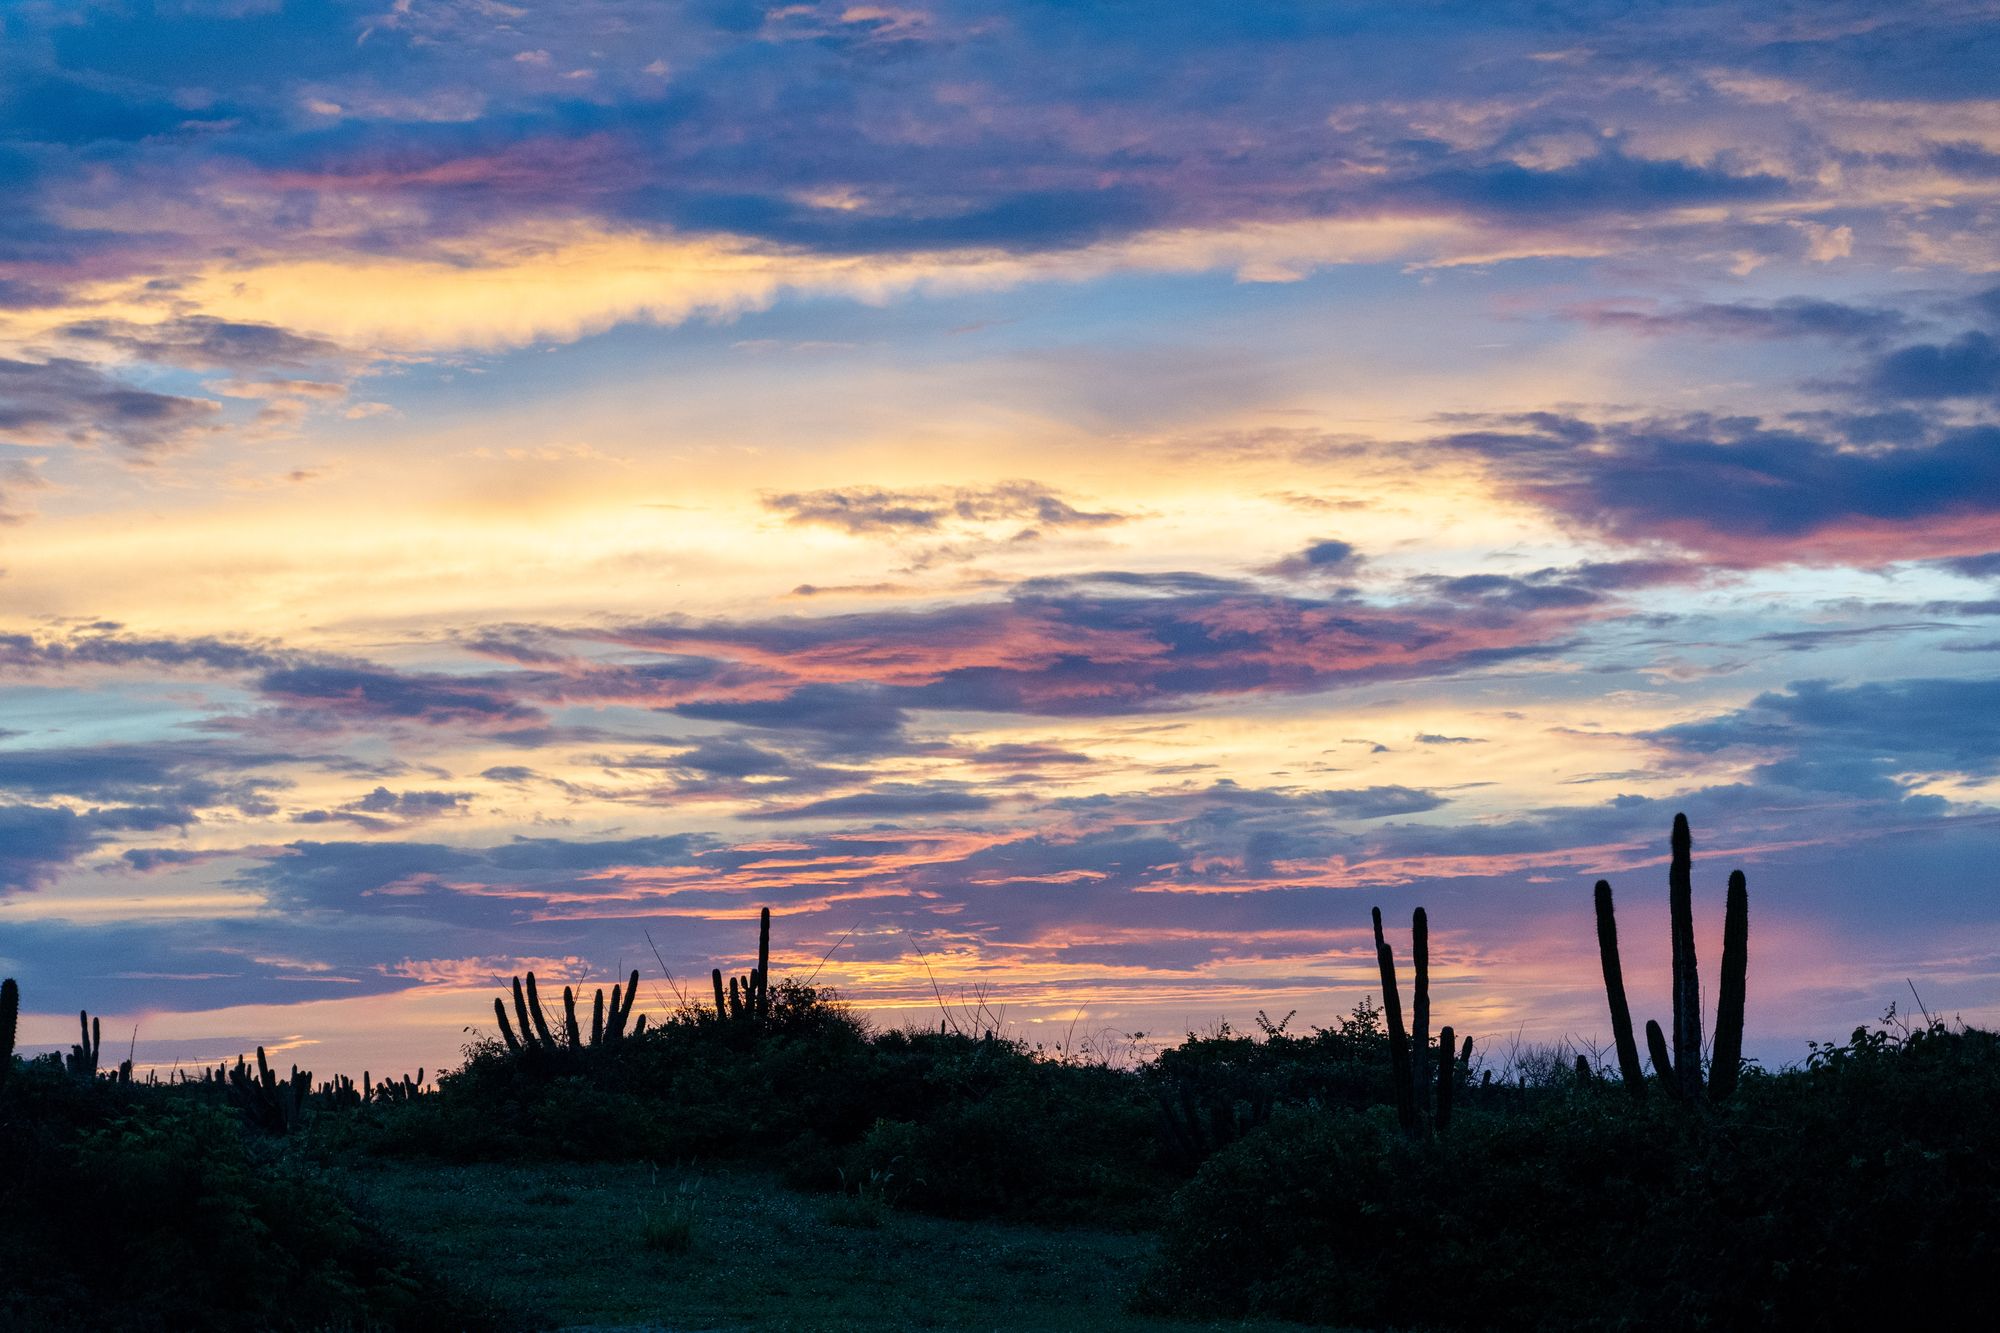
[1144,1012,2000,1329]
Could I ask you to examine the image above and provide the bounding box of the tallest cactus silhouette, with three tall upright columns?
[1596,815,1750,1103]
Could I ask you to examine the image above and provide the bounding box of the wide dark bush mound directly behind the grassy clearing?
[360,985,1172,1221]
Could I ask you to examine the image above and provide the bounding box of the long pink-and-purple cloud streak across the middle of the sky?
[610,570,1606,720]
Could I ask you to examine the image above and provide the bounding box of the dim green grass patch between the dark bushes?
[354,1161,1328,1333]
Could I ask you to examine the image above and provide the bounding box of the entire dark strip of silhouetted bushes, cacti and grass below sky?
[0,819,2000,1329]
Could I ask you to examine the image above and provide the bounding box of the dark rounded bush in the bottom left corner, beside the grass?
[0,1061,488,1329]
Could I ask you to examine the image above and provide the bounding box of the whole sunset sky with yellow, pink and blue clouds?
[0,0,2000,1075]
